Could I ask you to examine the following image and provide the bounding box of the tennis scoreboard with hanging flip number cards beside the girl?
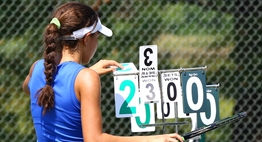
[113,45,220,141]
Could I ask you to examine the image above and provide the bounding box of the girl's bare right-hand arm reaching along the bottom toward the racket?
[75,68,182,142]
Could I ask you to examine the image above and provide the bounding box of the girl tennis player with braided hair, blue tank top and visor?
[23,2,182,142]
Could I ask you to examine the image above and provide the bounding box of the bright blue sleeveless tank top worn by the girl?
[28,59,84,142]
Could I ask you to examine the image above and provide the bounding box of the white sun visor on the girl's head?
[71,18,113,39]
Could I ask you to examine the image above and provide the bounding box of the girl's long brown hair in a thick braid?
[37,2,97,114]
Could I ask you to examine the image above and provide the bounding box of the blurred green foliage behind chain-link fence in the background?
[0,0,262,142]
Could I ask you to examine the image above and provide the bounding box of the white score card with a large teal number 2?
[114,63,139,118]
